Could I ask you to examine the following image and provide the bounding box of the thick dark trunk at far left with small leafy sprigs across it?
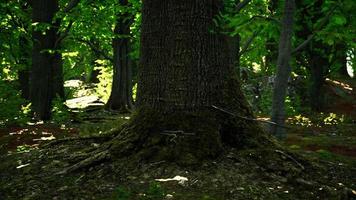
[30,0,64,120]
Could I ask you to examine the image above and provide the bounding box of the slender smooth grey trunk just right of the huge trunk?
[270,0,295,138]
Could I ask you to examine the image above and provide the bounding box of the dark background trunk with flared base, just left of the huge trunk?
[106,0,133,112]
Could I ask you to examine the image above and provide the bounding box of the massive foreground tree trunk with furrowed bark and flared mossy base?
[113,0,267,164]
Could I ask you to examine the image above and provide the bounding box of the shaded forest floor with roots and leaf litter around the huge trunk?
[0,76,356,200]
